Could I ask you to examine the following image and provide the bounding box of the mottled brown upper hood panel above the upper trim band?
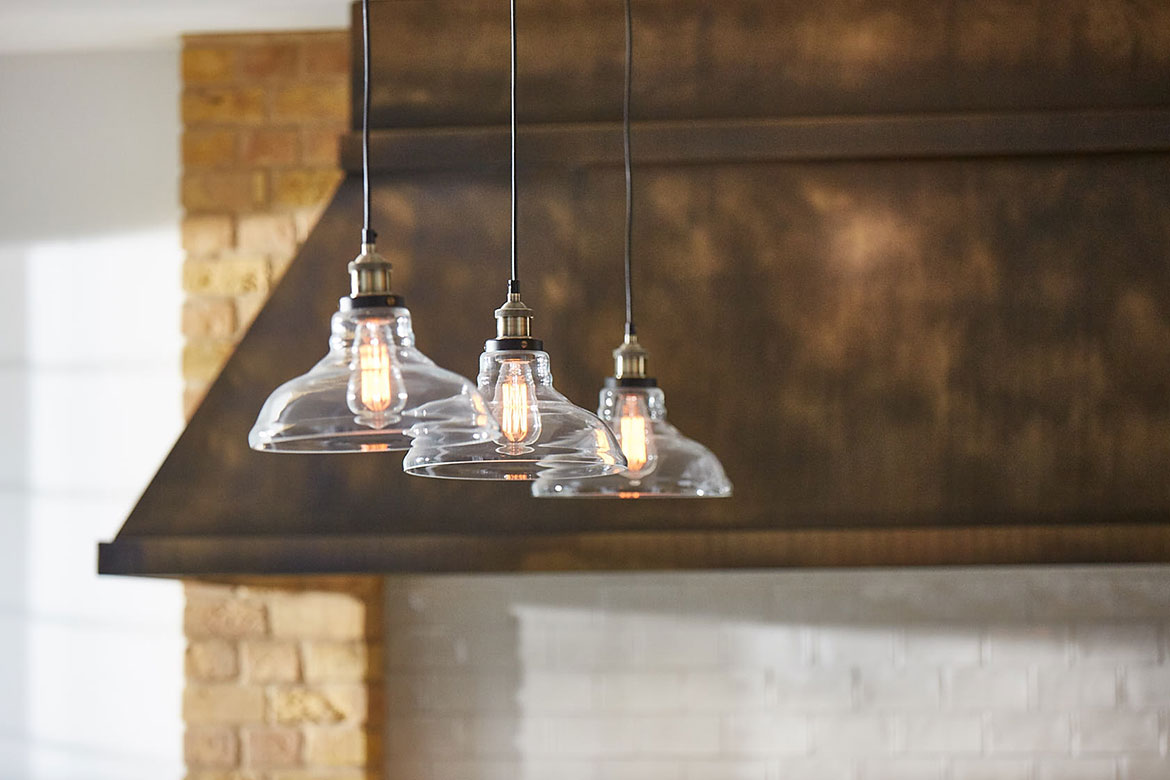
[353,0,1170,129]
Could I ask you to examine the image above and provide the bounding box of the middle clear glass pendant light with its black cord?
[402,0,626,481]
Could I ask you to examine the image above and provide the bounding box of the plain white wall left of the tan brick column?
[0,50,184,780]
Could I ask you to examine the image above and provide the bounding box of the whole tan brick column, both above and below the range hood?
[181,32,384,780]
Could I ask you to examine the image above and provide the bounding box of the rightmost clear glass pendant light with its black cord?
[532,0,731,498]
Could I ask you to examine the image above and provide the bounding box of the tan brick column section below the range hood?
[183,578,384,780]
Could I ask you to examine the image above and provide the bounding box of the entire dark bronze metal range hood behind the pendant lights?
[98,0,1170,577]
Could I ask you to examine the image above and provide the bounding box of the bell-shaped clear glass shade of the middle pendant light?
[402,350,626,481]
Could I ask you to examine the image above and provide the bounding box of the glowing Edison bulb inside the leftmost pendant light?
[345,319,406,428]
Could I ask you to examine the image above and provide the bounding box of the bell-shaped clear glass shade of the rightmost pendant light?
[532,387,731,498]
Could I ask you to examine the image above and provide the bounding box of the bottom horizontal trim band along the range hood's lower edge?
[98,524,1170,577]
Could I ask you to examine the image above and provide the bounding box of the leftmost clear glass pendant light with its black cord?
[248,0,498,453]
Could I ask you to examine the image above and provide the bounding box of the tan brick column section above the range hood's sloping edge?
[181,32,350,414]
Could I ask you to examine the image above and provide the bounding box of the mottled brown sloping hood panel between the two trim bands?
[111,156,1170,549]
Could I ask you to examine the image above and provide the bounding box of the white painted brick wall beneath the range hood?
[386,567,1170,780]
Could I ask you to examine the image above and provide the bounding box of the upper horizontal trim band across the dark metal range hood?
[342,109,1170,173]
